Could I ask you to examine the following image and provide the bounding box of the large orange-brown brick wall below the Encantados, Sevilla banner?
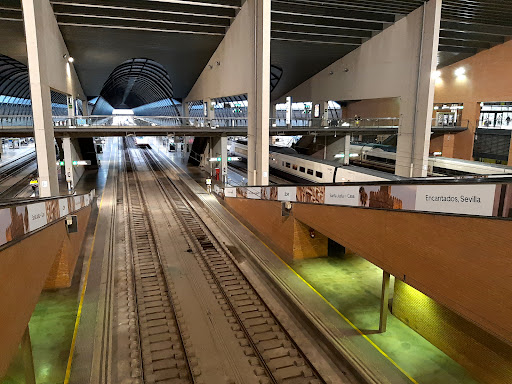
[226,198,512,345]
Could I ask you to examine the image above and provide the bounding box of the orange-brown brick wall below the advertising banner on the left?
[0,206,91,377]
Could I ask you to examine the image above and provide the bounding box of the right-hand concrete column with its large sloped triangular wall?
[272,0,441,177]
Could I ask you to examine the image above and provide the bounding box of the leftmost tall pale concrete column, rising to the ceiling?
[21,0,59,197]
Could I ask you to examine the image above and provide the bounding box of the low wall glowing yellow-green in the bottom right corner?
[393,280,512,384]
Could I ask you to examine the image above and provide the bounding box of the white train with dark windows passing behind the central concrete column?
[230,141,402,183]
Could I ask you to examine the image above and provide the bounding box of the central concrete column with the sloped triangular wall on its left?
[185,0,270,185]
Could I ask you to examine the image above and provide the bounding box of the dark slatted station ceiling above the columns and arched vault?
[0,0,512,99]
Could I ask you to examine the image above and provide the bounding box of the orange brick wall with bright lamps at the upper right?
[434,41,512,159]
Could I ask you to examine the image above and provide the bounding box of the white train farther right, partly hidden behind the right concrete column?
[350,144,512,176]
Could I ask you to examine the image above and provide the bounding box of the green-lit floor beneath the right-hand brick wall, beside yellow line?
[291,255,477,384]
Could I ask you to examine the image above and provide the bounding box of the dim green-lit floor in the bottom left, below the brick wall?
[0,287,78,384]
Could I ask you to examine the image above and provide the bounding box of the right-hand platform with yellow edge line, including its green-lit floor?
[155,150,478,384]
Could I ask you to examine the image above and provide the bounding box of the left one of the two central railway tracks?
[125,142,199,384]
